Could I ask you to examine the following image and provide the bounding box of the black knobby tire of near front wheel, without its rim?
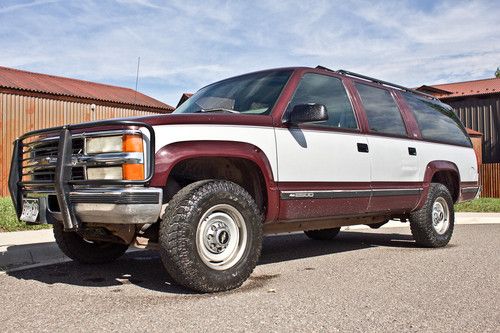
[159,180,262,292]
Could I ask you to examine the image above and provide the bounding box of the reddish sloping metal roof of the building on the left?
[0,66,174,112]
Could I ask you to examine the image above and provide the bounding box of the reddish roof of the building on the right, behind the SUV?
[418,78,500,99]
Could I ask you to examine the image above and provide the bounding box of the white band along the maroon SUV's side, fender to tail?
[154,124,478,182]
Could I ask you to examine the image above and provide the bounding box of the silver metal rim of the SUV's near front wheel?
[196,204,247,270]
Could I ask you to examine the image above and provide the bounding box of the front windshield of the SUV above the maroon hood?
[174,70,292,115]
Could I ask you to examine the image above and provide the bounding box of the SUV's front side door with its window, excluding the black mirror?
[276,73,371,220]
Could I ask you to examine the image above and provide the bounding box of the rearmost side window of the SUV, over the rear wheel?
[404,93,471,147]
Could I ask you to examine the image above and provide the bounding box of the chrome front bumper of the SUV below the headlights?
[31,187,162,224]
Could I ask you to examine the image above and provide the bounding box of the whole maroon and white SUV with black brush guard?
[9,67,479,292]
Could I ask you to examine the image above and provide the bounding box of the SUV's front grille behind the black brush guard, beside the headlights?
[21,137,85,183]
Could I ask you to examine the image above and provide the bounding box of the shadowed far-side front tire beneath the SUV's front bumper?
[53,221,128,264]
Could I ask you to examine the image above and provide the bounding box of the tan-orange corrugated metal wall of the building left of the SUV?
[0,93,168,196]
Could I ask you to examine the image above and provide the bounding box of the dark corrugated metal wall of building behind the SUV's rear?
[450,94,500,163]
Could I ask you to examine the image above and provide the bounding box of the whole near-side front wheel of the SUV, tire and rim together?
[159,180,262,292]
